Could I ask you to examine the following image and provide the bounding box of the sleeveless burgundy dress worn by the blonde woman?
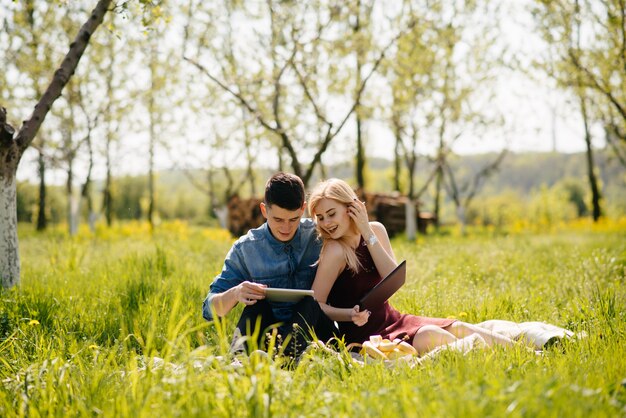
[327,238,455,343]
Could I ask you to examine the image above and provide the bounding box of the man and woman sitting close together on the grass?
[202,173,514,357]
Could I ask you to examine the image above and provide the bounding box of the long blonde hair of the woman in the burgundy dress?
[309,178,361,273]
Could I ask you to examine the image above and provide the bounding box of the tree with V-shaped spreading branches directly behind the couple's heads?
[180,0,412,183]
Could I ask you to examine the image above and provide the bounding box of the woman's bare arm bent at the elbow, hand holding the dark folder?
[312,241,369,326]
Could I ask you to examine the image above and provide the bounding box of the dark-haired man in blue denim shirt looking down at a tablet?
[202,173,336,356]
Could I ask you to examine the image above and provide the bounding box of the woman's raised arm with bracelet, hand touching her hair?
[348,200,398,277]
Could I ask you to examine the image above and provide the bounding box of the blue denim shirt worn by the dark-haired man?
[202,219,322,321]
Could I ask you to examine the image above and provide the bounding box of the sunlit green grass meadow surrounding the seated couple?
[0,223,626,417]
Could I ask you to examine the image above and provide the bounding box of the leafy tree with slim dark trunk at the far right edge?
[532,0,626,221]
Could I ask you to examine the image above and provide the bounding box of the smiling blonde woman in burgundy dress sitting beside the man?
[309,179,513,355]
